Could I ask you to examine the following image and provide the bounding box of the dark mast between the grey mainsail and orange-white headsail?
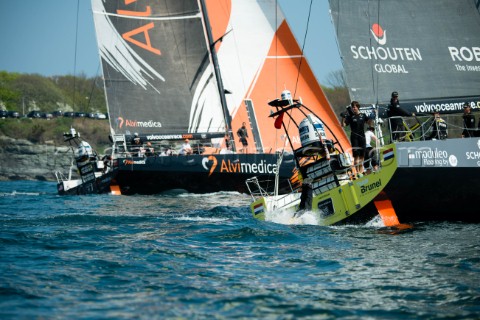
[199,0,235,151]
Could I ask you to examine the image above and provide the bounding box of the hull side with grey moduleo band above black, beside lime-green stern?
[385,138,480,223]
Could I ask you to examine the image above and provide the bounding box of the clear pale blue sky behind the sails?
[0,0,342,85]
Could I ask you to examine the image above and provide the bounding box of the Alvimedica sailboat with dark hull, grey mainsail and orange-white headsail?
[92,0,349,194]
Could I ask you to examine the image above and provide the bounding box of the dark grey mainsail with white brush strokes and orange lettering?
[92,0,225,136]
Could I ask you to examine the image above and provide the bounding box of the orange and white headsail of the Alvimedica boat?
[207,0,349,153]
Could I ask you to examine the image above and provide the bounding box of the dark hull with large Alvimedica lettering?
[116,154,294,195]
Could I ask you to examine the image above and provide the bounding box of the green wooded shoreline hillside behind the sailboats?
[0,70,350,147]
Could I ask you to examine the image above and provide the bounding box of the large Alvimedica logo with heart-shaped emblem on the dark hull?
[202,156,277,176]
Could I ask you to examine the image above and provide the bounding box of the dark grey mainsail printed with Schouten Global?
[329,0,480,113]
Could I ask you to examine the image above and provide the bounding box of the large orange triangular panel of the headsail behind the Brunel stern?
[233,21,350,152]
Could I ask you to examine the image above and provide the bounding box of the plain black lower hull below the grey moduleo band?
[385,168,480,223]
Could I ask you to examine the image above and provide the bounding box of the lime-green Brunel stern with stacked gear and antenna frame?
[247,91,400,227]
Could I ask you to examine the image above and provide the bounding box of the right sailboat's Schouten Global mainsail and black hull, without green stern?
[329,0,480,222]
